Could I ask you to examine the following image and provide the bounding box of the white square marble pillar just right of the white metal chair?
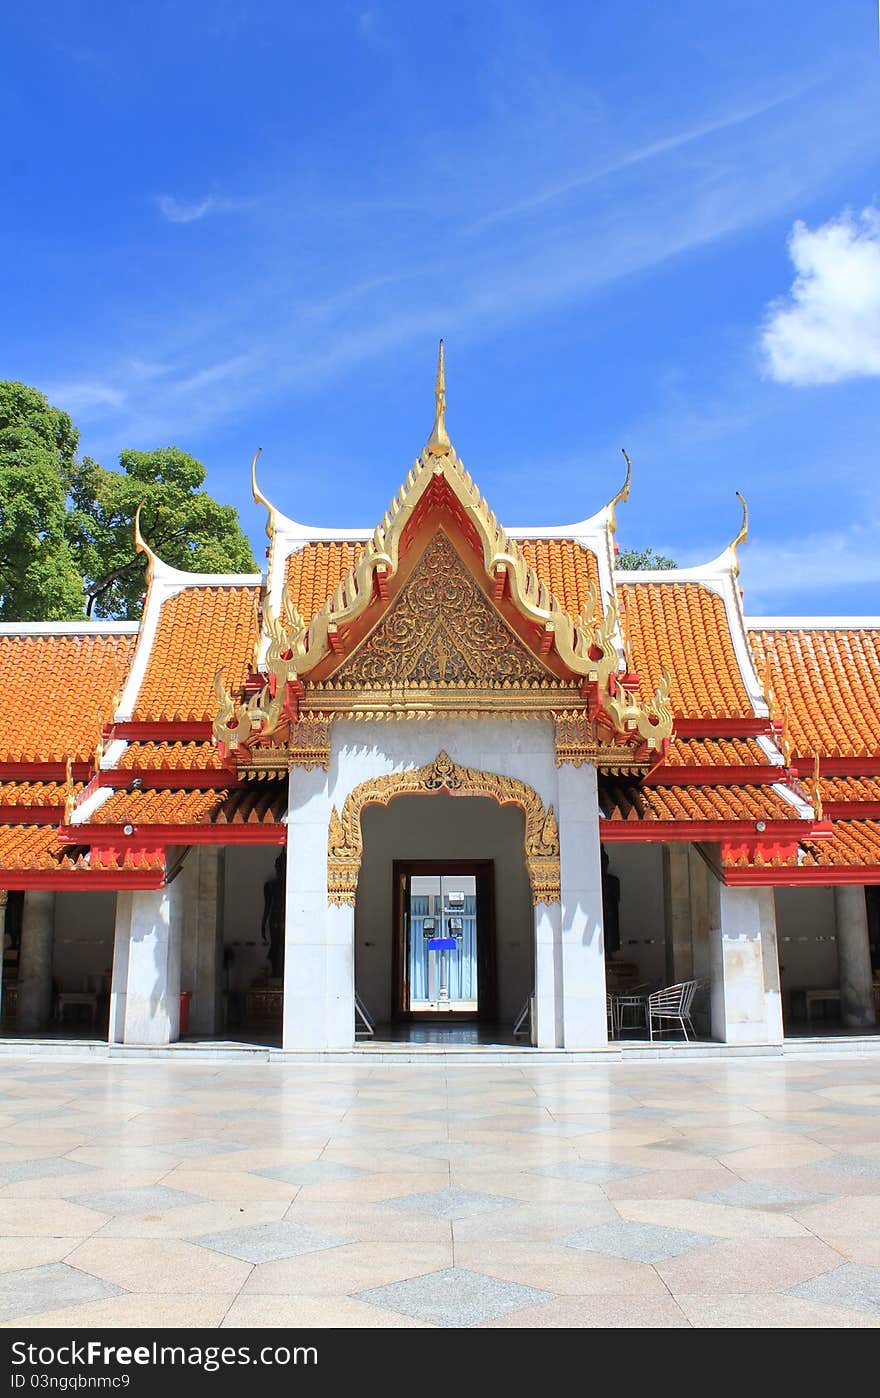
[709,881,782,1044]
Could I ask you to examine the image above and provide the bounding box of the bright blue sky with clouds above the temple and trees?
[0,0,880,614]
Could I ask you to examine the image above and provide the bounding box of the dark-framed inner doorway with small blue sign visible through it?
[392,860,498,1021]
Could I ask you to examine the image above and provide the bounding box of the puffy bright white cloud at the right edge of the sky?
[762,208,880,384]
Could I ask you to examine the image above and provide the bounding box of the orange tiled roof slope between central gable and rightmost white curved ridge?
[618,583,753,719]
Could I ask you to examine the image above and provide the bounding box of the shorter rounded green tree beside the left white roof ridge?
[67,446,256,618]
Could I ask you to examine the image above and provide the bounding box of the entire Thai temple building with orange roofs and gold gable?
[0,345,880,1051]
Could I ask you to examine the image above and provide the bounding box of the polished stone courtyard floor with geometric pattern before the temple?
[0,1053,880,1328]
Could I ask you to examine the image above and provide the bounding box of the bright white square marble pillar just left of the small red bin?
[109,877,185,1044]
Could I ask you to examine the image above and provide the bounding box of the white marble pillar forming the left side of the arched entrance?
[281,768,354,1050]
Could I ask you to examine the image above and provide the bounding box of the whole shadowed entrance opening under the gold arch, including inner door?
[354,793,534,1043]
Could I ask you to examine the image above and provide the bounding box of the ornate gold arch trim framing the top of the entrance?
[327,752,560,906]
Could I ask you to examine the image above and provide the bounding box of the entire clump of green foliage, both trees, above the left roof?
[0,382,256,621]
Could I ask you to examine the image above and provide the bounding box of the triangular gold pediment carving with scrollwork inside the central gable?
[333,530,558,689]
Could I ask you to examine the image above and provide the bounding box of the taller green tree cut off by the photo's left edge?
[0,382,83,621]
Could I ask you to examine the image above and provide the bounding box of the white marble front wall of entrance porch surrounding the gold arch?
[283,719,606,1049]
